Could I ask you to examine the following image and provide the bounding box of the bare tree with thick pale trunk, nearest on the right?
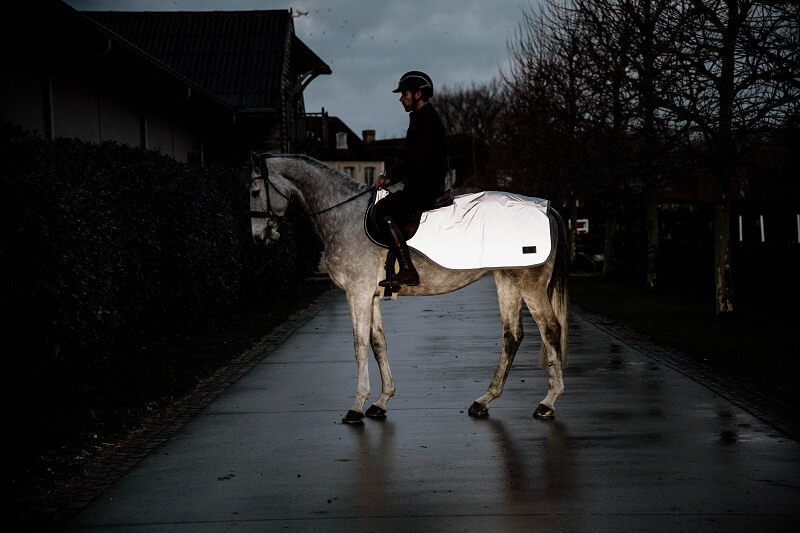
[665,0,800,314]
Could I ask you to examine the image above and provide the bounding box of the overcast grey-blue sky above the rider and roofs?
[67,0,537,139]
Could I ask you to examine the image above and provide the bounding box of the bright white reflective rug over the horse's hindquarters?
[408,191,551,270]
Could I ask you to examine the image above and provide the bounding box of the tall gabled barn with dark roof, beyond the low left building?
[86,10,331,160]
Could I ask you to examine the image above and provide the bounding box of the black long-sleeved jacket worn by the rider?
[386,103,447,211]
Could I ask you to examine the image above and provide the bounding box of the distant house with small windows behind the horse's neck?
[302,108,385,185]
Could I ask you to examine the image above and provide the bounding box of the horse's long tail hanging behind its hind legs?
[539,207,569,368]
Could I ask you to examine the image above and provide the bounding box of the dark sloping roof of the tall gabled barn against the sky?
[83,10,331,110]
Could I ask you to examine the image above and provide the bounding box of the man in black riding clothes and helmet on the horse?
[373,70,447,287]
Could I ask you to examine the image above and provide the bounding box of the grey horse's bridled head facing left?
[250,153,291,244]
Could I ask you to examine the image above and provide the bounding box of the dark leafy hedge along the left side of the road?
[0,119,321,386]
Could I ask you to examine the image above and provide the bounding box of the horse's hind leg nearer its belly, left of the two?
[469,272,523,417]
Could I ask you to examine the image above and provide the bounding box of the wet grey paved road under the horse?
[70,278,800,532]
